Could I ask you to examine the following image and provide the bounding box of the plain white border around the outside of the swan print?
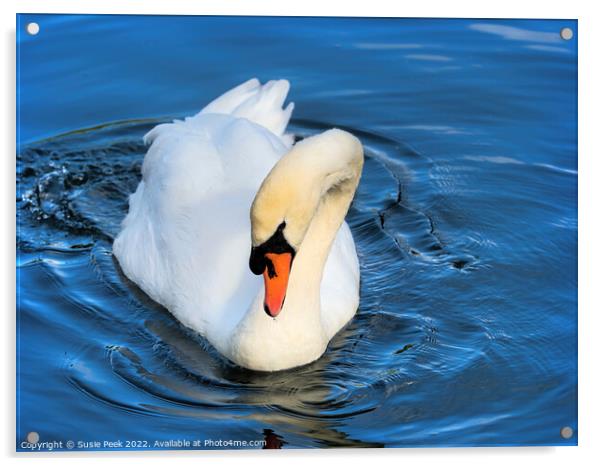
[0,0,602,466]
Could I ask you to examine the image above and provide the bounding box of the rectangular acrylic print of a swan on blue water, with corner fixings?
[16,14,578,451]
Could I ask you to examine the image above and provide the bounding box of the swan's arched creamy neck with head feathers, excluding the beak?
[224,130,364,370]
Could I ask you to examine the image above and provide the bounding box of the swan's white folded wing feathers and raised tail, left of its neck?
[113,80,290,335]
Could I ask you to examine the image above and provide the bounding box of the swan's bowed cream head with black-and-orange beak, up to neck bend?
[249,129,363,317]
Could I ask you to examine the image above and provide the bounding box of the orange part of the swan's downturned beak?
[263,252,293,317]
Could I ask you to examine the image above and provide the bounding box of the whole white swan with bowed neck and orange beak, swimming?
[113,79,364,371]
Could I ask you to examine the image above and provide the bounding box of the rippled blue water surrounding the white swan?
[16,15,578,449]
